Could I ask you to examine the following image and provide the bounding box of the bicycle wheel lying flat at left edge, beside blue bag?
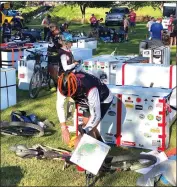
[0,121,44,137]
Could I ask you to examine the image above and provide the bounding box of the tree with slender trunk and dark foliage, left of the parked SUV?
[65,1,115,23]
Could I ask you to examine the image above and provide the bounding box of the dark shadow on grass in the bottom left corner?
[1,166,24,187]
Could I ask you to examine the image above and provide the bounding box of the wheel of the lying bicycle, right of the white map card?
[103,154,157,171]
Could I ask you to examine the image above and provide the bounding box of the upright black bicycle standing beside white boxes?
[26,50,54,99]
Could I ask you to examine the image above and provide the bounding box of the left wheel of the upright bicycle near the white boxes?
[29,70,42,99]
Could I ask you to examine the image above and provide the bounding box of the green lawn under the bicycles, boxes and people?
[1,21,176,186]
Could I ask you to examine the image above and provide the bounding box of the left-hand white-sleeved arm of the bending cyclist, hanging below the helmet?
[56,89,66,125]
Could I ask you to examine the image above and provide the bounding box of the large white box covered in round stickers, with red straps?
[75,85,172,151]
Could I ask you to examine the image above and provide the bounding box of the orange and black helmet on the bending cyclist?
[58,71,77,97]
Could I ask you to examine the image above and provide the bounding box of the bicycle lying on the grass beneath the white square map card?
[10,131,157,186]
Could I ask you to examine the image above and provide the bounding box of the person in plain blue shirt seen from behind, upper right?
[150,18,163,40]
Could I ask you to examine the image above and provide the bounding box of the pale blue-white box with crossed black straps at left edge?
[0,68,17,110]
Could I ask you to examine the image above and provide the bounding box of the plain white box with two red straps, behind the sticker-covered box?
[115,64,177,121]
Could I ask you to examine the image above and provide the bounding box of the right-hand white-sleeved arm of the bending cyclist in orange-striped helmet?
[83,88,101,133]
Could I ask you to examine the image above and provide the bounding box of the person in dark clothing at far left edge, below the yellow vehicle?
[2,19,12,43]
